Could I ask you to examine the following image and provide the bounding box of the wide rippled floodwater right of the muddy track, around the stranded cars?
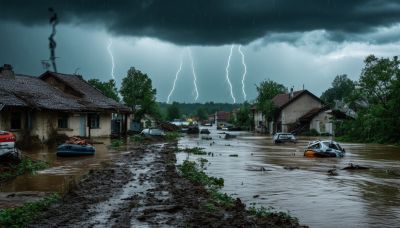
[178,129,400,227]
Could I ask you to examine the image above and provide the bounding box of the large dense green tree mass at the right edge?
[343,55,400,143]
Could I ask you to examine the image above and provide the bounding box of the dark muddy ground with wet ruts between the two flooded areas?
[29,144,299,227]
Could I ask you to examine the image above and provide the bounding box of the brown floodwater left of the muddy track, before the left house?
[0,138,128,208]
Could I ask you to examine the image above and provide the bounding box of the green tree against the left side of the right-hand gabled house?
[256,79,287,120]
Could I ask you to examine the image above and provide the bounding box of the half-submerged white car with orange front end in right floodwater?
[304,140,346,158]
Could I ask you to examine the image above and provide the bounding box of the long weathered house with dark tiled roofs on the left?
[0,64,131,141]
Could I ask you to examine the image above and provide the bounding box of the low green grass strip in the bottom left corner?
[0,194,60,227]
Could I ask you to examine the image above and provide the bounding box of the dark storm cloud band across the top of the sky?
[0,0,400,45]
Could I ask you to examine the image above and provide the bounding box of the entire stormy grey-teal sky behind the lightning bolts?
[0,0,400,102]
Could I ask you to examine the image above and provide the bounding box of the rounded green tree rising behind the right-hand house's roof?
[321,74,355,107]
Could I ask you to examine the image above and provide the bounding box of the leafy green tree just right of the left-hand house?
[120,67,159,121]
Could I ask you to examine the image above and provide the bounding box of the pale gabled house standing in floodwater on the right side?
[253,90,333,134]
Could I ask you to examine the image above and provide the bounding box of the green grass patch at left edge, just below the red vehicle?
[0,158,50,182]
